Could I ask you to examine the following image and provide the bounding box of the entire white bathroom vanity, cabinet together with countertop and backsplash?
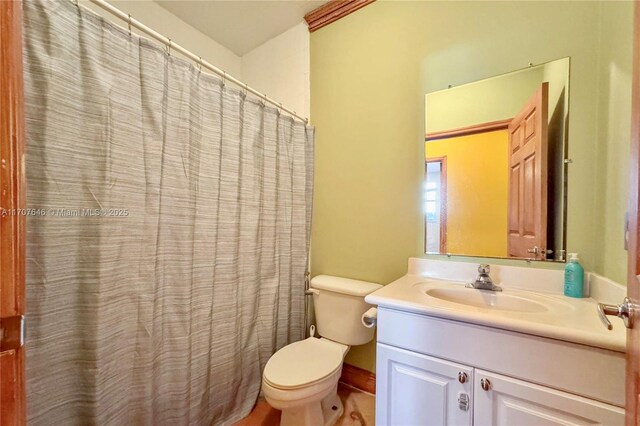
[366,259,626,426]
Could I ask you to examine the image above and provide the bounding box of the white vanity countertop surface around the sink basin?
[365,274,626,352]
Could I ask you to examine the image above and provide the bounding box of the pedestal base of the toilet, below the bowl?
[280,384,344,426]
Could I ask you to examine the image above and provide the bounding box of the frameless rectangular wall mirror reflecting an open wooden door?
[423,58,570,261]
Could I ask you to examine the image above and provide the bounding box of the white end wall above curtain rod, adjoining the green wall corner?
[242,22,310,117]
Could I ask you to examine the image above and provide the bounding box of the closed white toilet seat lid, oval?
[263,337,345,389]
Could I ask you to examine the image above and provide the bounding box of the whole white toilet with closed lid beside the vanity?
[262,275,382,426]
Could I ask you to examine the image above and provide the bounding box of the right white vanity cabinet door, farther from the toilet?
[473,369,624,426]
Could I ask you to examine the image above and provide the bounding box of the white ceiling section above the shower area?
[155,0,326,56]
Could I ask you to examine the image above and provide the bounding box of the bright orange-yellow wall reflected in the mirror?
[425,130,509,257]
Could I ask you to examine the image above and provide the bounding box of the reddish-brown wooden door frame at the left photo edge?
[0,0,26,426]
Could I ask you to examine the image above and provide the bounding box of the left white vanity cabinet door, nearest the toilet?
[376,343,473,426]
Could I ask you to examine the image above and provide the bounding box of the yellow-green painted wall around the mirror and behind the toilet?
[311,0,633,371]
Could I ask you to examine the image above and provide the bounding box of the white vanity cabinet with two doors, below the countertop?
[376,308,624,426]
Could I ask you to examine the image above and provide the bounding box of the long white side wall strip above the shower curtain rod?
[80,0,242,78]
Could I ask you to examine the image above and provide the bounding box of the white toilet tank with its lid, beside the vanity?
[311,275,382,346]
